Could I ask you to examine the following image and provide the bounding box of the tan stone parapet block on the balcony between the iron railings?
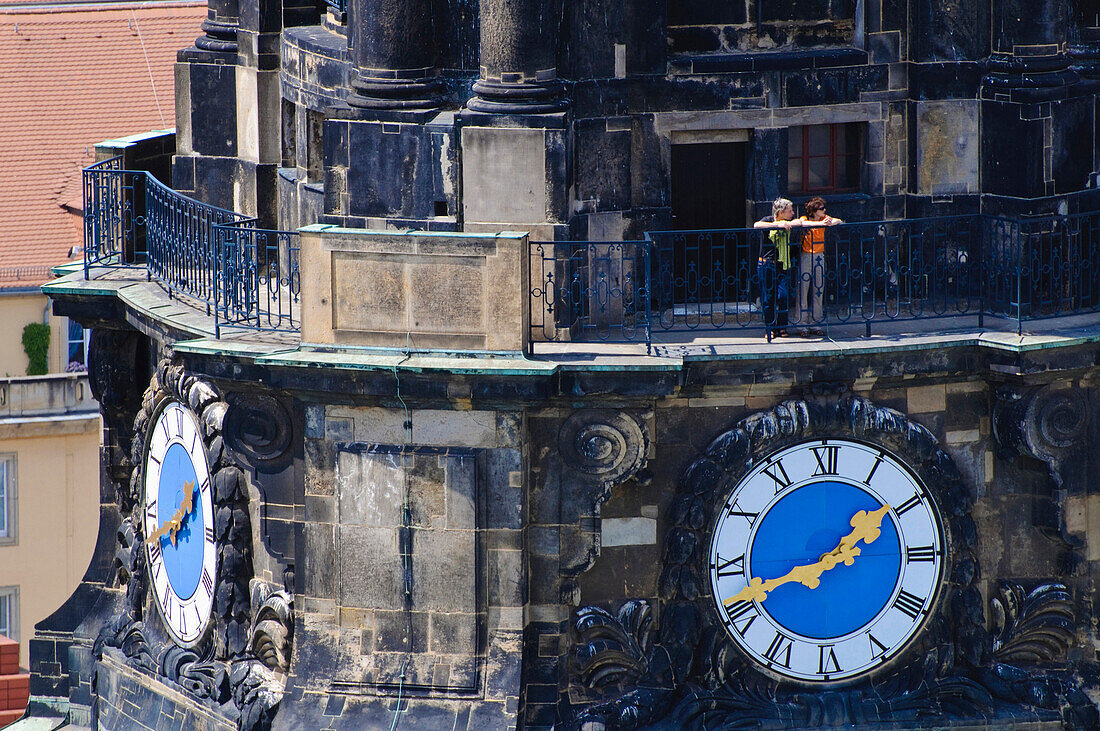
[301,225,529,352]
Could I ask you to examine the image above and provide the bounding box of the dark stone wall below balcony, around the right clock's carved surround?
[523,367,1100,728]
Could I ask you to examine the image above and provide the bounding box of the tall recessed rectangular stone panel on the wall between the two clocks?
[333,442,481,690]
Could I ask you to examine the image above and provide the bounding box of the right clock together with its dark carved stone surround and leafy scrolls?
[570,397,1100,730]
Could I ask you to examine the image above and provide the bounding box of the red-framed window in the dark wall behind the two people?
[787,122,862,196]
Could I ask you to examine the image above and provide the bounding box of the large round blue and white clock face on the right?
[710,439,945,683]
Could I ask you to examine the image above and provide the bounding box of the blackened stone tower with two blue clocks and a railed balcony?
[21,0,1100,729]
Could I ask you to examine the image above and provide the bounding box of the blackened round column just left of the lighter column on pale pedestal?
[348,0,441,110]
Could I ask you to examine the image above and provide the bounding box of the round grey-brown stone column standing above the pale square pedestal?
[468,0,568,114]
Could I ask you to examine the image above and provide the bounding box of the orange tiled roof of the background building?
[0,0,207,289]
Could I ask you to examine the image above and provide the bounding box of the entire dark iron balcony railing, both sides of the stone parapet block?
[84,158,1100,347]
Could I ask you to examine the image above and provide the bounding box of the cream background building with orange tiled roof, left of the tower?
[0,2,205,703]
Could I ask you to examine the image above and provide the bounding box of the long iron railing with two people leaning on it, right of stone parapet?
[531,213,1100,346]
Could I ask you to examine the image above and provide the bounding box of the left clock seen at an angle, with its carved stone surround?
[94,363,294,730]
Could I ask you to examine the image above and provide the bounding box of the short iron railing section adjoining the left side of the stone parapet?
[215,219,301,334]
